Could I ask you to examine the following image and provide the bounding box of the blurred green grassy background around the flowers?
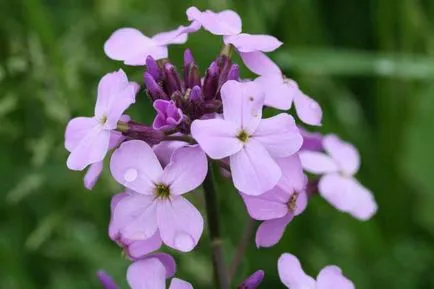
[0,0,434,289]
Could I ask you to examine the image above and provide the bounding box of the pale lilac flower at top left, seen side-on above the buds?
[104,25,198,66]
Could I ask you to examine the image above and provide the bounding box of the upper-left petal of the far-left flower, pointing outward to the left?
[65,117,98,152]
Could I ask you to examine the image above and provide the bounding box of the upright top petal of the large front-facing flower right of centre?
[221,80,264,133]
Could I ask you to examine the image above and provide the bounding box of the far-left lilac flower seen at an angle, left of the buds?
[65,69,139,171]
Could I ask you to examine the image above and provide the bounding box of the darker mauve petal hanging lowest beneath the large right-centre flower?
[255,214,293,248]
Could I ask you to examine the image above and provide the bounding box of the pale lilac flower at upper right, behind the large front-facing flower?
[255,72,322,126]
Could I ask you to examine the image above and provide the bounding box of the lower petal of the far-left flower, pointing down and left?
[66,126,110,171]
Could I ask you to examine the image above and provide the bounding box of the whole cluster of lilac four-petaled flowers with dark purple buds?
[65,7,377,289]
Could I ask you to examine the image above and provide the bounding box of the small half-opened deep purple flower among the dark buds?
[152,99,183,129]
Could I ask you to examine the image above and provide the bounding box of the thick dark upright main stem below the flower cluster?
[202,164,229,289]
